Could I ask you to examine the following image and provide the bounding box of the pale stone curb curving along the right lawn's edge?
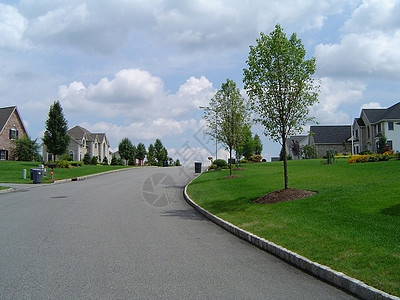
[183,183,400,300]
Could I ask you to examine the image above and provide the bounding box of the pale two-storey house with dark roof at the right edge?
[353,102,400,153]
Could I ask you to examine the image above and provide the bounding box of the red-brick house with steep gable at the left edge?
[0,106,28,160]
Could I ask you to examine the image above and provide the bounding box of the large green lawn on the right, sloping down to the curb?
[188,160,400,296]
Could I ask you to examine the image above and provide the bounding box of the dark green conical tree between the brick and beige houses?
[43,101,69,161]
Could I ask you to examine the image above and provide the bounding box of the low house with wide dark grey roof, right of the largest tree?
[309,125,351,157]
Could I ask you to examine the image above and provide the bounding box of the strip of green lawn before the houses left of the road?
[0,161,127,183]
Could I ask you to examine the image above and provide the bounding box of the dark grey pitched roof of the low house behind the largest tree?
[310,125,351,144]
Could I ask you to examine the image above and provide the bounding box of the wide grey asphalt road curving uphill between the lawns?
[0,168,352,299]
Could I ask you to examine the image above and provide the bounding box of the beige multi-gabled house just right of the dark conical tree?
[43,126,111,163]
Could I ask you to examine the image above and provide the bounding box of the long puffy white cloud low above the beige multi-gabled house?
[58,69,215,120]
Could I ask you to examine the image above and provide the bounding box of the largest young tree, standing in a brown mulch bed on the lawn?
[243,25,318,189]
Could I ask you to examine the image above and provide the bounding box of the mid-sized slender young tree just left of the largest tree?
[203,79,249,175]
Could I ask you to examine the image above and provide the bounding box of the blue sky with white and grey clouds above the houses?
[0,0,400,162]
